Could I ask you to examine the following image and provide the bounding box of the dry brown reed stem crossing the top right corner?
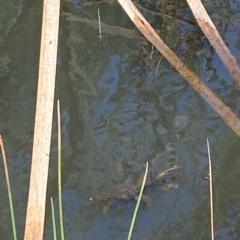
[187,0,240,87]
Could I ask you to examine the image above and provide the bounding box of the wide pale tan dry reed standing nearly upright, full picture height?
[24,0,60,240]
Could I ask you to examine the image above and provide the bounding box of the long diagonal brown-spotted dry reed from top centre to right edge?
[118,0,240,137]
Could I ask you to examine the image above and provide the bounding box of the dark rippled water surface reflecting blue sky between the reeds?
[0,0,240,240]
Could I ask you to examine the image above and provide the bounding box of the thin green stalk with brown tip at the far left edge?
[0,135,17,240]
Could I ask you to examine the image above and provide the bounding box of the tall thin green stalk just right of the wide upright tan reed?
[57,100,64,240]
